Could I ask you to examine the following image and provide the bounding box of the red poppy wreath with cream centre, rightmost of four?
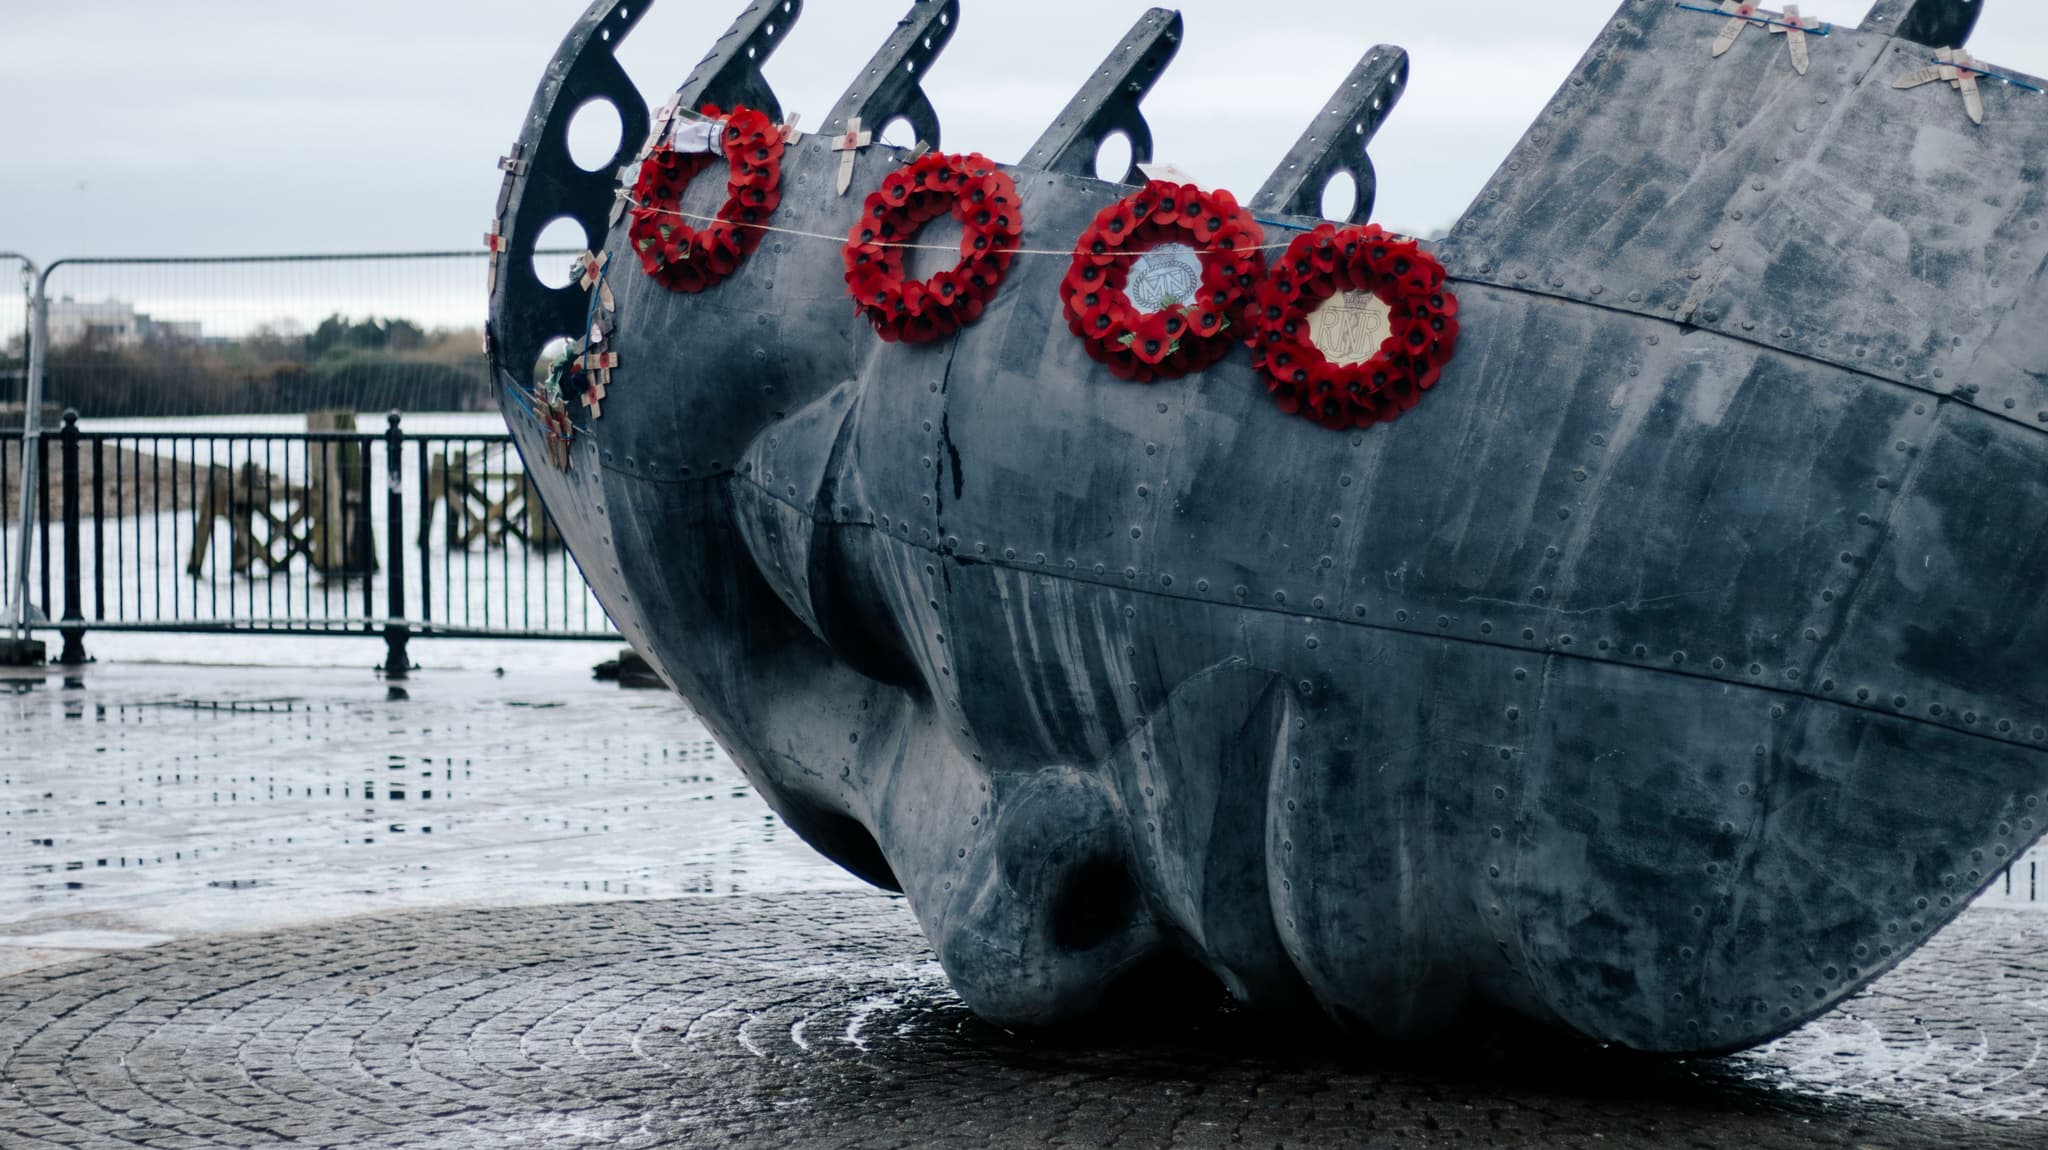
[1253,223,1458,428]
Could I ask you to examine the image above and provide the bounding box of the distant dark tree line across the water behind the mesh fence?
[45,315,492,419]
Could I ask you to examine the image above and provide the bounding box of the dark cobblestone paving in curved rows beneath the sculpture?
[0,892,2048,1150]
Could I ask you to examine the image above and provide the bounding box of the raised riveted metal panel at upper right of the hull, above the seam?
[1444,0,2048,433]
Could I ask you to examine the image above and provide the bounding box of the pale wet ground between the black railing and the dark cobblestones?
[0,665,858,970]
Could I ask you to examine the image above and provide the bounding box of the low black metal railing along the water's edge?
[0,411,616,671]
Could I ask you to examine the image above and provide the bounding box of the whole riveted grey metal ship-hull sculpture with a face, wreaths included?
[489,0,2048,1052]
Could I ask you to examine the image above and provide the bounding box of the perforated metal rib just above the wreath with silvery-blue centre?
[1024,8,1182,184]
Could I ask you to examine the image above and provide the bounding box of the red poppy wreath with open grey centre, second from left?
[844,153,1024,344]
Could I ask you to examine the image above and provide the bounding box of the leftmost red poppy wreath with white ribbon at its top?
[627,104,782,293]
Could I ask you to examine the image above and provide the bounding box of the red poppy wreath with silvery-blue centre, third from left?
[1059,180,1266,383]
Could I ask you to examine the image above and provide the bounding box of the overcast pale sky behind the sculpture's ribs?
[0,0,2048,260]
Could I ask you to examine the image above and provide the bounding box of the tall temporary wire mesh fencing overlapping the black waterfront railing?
[0,248,616,671]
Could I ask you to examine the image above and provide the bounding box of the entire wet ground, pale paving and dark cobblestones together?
[0,650,2048,1150]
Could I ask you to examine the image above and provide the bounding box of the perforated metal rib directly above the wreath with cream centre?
[1251,43,1407,223]
